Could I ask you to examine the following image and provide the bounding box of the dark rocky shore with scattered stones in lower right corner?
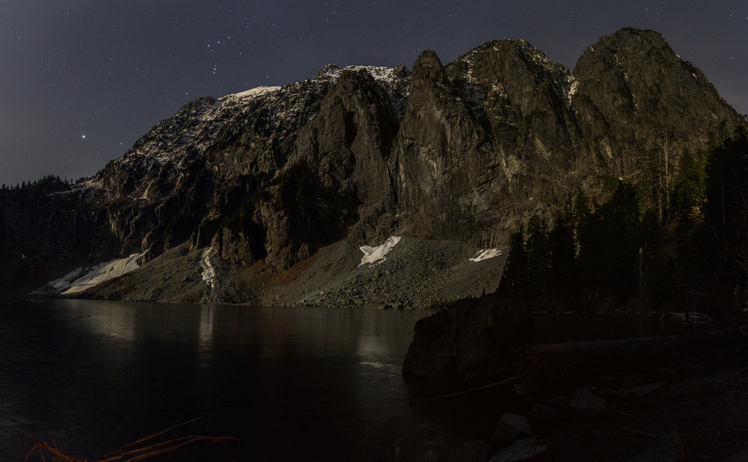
[351,326,748,462]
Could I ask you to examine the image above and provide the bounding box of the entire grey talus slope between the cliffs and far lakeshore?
[79,237,505,309]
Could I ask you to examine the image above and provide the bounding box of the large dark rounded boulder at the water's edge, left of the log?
[403,296,533,378]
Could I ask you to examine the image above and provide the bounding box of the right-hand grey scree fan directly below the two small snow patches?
[272,237,505,309]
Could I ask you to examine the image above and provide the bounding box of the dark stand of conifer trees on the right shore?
[498,129,748,314]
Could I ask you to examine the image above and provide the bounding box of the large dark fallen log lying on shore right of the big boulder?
[516,328,741,388]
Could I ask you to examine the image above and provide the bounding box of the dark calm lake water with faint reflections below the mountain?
[0,300,450,460]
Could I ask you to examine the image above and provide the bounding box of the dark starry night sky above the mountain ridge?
[0,0,748,184]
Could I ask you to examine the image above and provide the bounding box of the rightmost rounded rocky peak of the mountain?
[571,29,745,176]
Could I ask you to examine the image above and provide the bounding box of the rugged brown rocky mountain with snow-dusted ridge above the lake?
[0,29,745,301]
